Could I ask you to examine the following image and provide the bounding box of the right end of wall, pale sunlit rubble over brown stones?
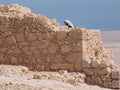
[82,30,120,88]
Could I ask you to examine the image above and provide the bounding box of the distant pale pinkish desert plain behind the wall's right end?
[102,31,120,66]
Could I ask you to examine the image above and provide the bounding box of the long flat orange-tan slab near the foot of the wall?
[50,63,73,70]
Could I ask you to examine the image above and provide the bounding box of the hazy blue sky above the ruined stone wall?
[0,0,120,30]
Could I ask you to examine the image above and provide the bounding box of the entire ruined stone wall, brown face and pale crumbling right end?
[0,4,120,89]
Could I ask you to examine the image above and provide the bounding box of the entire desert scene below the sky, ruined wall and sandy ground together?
[0,4,120,90]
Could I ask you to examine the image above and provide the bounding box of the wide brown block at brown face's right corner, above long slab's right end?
[66,53,82,62]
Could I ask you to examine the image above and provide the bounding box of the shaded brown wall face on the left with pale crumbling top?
[0,5,82,71]
